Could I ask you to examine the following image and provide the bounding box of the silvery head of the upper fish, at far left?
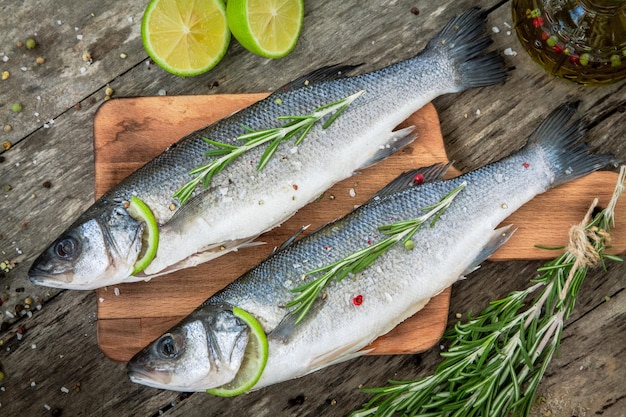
[28,203,145,290]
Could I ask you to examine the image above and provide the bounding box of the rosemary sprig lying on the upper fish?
[173,90,365,205]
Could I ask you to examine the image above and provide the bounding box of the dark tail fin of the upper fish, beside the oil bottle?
[427,7,507,91]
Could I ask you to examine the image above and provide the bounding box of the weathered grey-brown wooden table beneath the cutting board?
[0,0,626,416]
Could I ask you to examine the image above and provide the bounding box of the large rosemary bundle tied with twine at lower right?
[352,167,626,417]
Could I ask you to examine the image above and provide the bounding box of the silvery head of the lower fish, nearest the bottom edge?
[127,305,249,392]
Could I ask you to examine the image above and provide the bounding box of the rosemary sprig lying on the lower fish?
[285,182,467,323]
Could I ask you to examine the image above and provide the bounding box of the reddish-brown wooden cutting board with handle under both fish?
[94,94,626,361]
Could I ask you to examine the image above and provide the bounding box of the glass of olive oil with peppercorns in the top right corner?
[513,0,626,85]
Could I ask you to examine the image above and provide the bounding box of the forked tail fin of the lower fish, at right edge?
[526,102,619,186]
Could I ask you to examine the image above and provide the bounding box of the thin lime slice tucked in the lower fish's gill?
[206,306,268,397]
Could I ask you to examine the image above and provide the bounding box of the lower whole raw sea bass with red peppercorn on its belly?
[128,105,613,391]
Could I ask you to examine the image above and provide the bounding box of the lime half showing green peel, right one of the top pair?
[226,0,304,58]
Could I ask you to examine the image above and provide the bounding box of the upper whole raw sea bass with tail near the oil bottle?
[29,9,506,289]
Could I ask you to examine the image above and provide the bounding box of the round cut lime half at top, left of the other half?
[141,0,230,77]
